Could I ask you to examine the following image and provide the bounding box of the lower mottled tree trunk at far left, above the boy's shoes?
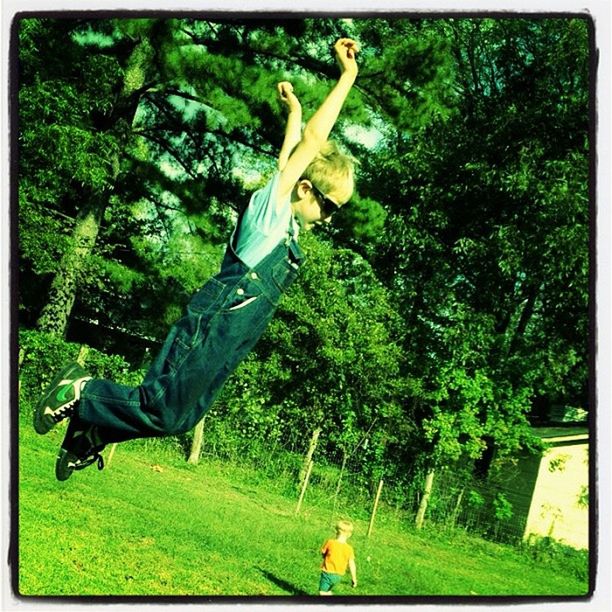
[37,203,104,336]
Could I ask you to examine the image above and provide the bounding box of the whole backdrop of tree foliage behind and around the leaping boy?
[17,16,590,502]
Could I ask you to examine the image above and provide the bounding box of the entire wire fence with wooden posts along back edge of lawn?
[19,332,588,542]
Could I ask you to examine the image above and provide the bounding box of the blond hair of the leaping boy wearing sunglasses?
[302,140,356,204]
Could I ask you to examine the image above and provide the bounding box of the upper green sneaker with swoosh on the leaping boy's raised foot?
[34,363,91,434]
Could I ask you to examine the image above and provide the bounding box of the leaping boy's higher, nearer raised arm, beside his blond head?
[277,38,359,201]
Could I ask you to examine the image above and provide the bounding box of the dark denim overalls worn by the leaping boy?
[78,221,304,443]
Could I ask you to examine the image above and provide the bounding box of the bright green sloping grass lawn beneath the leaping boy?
[16,412,588,597]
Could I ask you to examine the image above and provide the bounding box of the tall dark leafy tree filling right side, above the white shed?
[362,19,589,465]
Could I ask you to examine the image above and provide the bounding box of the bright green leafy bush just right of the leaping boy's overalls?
[182,236,401,479]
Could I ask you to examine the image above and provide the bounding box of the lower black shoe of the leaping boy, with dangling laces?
[55,417,105,480]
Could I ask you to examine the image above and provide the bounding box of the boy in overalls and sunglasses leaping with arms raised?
[34,38,359,480]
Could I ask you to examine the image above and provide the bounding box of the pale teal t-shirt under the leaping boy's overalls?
[234,172,299,268]
